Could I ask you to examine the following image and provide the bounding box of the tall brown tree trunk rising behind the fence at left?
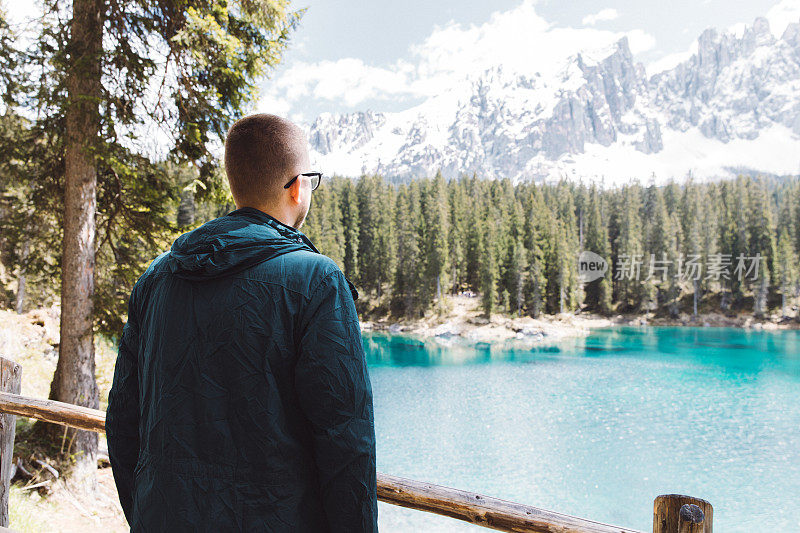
[39,0,105,492]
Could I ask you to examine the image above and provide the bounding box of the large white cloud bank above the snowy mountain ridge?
[259,0,655,114]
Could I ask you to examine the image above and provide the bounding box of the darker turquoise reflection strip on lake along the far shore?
[363,327,800,374]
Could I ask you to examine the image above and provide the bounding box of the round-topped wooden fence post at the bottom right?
[653,494,714,533]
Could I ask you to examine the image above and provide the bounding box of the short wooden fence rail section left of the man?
[0,392,106,433]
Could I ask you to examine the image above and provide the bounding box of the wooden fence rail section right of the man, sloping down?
[378,474,635,533]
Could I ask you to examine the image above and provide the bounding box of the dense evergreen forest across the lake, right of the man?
[302,174,800,317]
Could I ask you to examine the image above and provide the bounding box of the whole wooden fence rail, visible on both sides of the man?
[0,392,640,533]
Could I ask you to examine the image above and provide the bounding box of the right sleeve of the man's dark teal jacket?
[295,269,378,533]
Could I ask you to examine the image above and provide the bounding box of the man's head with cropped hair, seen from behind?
[225,113,311,229]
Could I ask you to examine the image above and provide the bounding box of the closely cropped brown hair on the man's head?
[225,113,306,205]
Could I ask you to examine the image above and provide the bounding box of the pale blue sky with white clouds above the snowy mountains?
[0,0,800,139]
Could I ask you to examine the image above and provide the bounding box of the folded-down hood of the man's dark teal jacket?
[165,207,358,300]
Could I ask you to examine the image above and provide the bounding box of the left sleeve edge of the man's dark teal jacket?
[106,286,139,524]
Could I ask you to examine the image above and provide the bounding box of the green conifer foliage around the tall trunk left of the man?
[0,0,300,335]
